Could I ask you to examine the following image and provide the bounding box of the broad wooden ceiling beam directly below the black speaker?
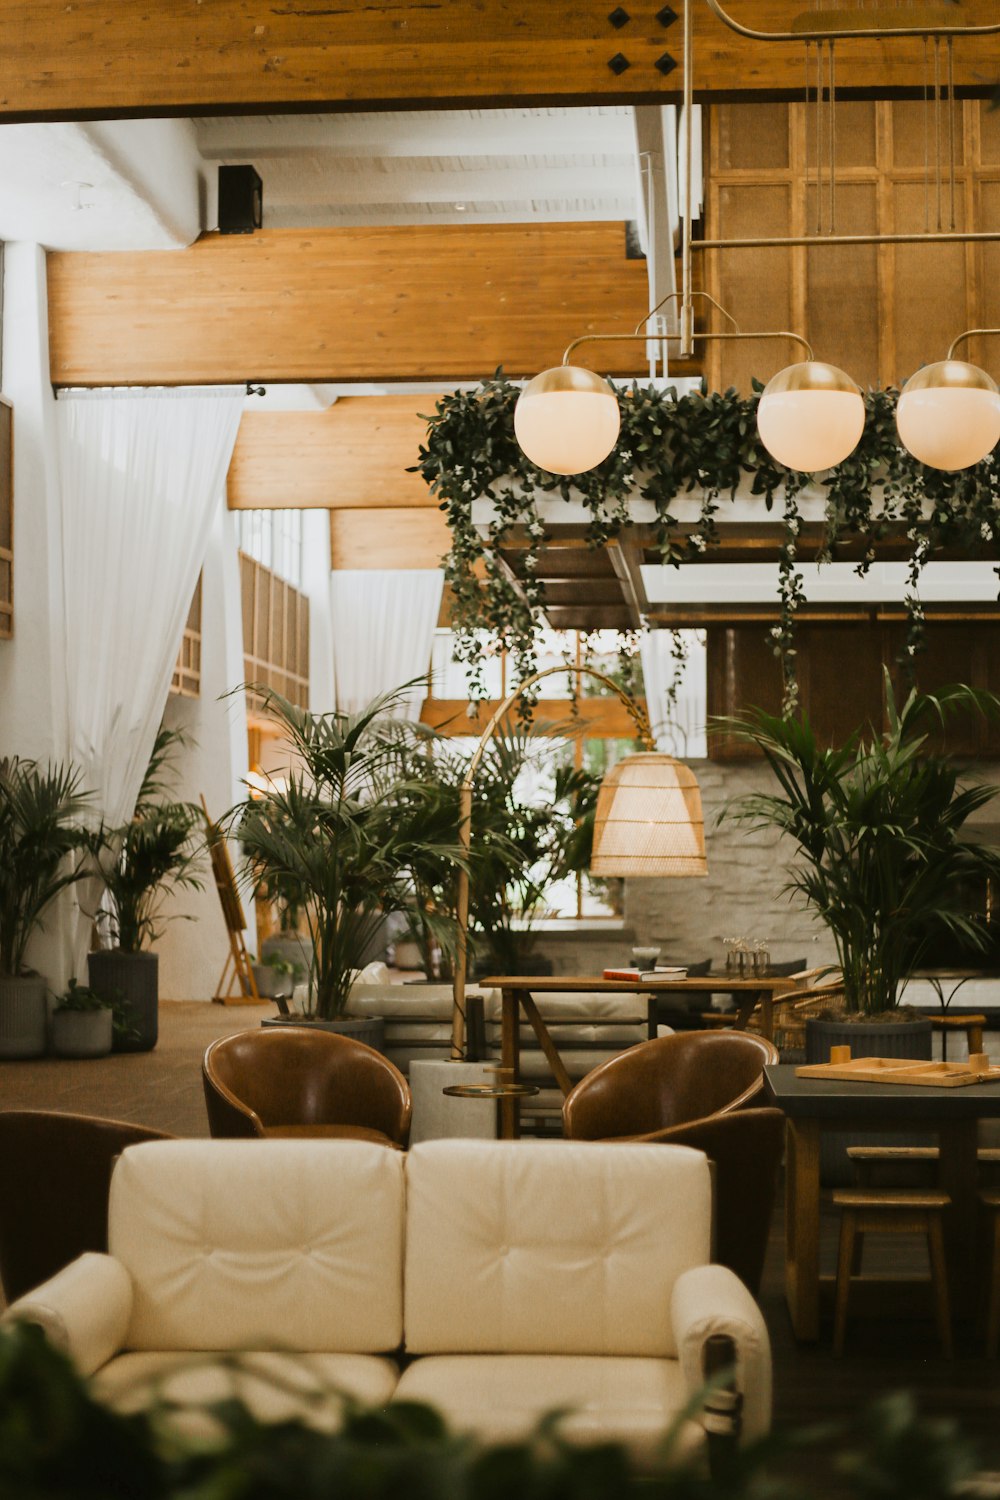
[48,224,648,386]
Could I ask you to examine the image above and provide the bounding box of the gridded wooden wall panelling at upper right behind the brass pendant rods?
[696,101,1000,392]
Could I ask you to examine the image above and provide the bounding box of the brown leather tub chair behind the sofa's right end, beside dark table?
[562,1031,784,1295]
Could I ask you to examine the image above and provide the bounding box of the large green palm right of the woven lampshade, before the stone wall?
[720,672,1000,1014]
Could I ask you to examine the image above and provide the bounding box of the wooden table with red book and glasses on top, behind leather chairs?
[477,974,796,1140]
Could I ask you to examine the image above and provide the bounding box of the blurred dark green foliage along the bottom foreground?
[0,1325,990,1500]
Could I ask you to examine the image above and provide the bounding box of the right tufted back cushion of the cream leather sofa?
[405,1140,712,1358]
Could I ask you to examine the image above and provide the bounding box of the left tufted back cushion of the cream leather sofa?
[108,1140,403,1355]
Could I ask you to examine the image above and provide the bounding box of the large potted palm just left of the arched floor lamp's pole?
[228,689,459,1031]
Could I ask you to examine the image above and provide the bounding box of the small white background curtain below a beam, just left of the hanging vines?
[330,569,444,722]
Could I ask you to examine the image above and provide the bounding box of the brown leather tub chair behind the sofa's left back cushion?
[201,1026,411,1148]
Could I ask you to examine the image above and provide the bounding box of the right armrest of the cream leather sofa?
[670,1266,771,1443]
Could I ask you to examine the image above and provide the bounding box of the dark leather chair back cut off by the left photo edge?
[0,1110,171,1302]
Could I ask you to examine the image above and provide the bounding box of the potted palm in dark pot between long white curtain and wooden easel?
[87,726,204,1052]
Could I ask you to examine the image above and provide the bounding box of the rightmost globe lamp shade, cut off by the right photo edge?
[897,360,1000,470]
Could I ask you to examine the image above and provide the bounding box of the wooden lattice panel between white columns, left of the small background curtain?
[240,552,309,710]
